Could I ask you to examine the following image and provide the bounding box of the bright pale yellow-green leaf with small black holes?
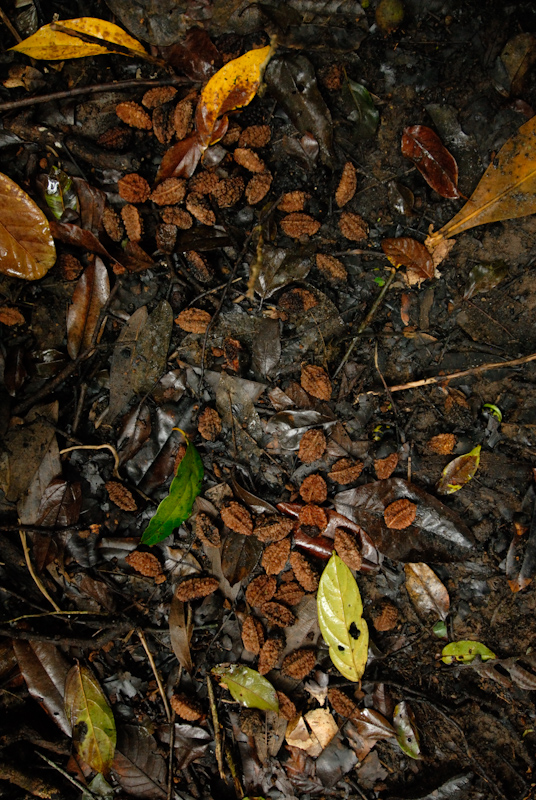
[317,553,368,681]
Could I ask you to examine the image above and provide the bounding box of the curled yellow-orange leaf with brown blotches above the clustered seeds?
[195,45,273,148]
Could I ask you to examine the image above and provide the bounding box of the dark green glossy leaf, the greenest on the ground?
[141,434,204,545]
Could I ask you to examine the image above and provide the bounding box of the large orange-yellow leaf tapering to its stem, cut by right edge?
[425,117,536,250]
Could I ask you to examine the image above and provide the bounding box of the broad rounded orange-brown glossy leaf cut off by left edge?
[0,173,56,281]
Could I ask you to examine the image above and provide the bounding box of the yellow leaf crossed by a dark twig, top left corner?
[10,17,147,61]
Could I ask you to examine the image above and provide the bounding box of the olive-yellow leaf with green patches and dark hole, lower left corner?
[65,664,116,775]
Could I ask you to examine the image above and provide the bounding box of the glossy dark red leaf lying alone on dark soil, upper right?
[402,125,461,200]
